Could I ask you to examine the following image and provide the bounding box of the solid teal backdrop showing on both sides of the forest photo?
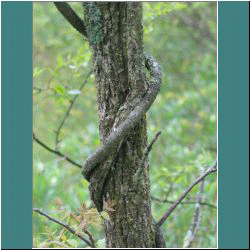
[1,2,249,249]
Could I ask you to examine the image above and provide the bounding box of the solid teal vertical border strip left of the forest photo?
[1,2,32,249]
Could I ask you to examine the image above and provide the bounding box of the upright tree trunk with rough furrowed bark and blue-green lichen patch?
[84,2,162,248]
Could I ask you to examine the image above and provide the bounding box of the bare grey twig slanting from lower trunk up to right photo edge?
[157,161,217,226]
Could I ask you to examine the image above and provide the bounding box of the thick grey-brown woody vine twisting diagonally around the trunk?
[82,54,161,212]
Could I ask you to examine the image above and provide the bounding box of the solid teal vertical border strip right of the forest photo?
[218,1,249,249]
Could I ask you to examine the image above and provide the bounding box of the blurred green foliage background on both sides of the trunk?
[33,2,217,248]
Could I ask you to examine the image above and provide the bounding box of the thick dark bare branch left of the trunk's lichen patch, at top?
[54,2,88,38]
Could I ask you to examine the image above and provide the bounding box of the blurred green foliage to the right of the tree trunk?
[144,2,217,247]
